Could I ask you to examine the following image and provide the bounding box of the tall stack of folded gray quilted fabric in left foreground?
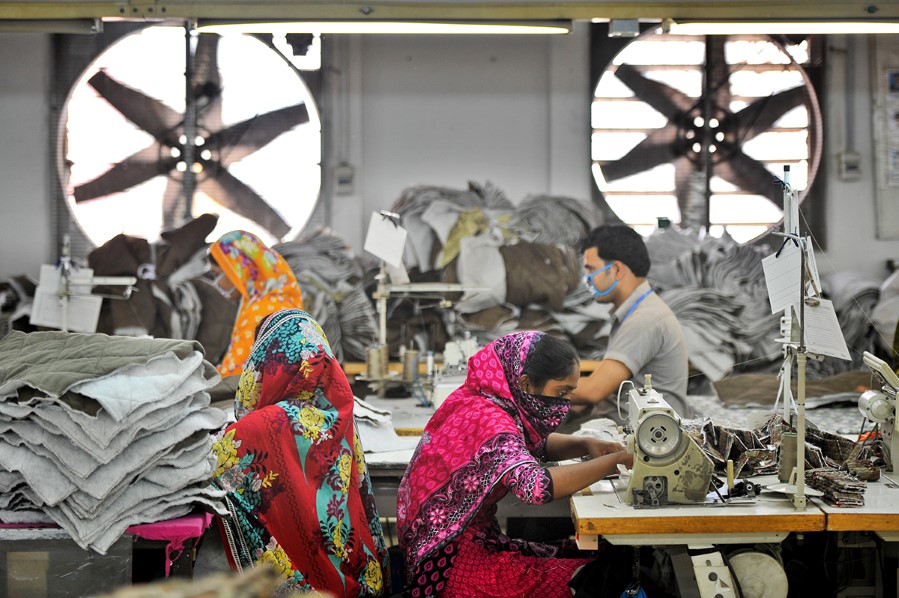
[0,331,226,554]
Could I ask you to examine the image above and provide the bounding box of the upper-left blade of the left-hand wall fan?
[88,71,184,146]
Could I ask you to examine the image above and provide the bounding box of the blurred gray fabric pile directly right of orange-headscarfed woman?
[274,229,378,361]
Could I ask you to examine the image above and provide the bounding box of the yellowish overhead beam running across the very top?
[0,0,899,20]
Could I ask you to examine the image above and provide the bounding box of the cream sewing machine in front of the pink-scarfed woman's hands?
[624,375,715,508]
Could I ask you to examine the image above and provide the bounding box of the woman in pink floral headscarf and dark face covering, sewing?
[397,332,632,598]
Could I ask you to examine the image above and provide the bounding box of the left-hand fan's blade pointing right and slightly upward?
[206,104,309,167]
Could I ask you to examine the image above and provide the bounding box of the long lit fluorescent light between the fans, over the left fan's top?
[197,21,572,35]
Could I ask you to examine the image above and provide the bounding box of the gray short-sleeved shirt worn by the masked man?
[605,282,690,417]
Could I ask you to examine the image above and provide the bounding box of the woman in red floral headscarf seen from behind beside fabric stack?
[213,309,389,597]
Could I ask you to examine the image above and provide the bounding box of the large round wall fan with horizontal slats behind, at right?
[592,31,823,239]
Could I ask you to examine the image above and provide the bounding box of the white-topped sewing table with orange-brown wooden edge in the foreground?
[571,476,825,548]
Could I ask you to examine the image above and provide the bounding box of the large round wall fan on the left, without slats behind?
[61,27,321,244]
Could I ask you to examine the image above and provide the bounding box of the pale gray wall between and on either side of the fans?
[0,26,899,288]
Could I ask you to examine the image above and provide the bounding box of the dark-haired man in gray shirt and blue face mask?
[566,225,691,424]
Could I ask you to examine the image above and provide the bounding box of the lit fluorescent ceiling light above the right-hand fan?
[662,20,899,35]
